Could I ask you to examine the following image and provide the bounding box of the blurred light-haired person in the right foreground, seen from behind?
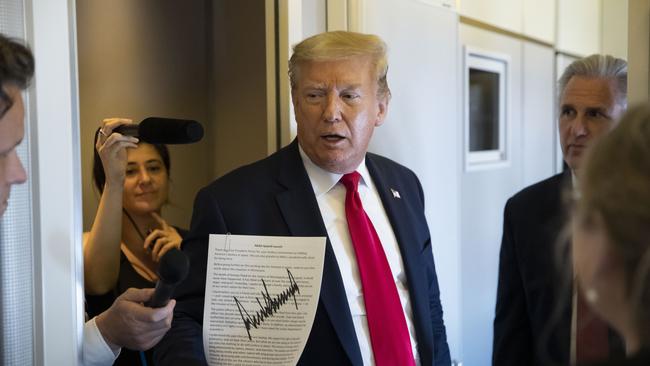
[573,105,650,366]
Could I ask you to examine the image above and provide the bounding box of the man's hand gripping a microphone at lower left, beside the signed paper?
[95,288,176,351]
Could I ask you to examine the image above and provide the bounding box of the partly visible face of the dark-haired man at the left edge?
[0,85,27,216]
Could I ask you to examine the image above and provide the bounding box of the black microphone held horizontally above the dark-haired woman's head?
[113,117,203,144]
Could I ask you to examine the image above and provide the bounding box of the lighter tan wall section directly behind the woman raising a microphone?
[77,0,212,230]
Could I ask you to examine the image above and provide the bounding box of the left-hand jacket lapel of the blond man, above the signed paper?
[276,140,363,365]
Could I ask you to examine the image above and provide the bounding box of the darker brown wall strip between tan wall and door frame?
[209,0,270,177]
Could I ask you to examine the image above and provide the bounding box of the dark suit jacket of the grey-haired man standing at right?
[492,171,623,366]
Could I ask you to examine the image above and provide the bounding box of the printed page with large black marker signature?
[203,234,326,366]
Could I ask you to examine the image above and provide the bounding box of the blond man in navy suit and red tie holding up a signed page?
[155,32,451,366]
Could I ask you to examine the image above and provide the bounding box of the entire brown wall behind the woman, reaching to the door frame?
[77,0,275,230]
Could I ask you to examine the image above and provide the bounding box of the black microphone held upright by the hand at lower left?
[144,248,190,308]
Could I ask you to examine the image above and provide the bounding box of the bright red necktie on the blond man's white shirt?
[341,172,415,366]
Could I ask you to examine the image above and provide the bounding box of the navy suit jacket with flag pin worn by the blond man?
[154,141,450,365]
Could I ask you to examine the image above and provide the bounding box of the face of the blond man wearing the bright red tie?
[291,56,388,174]
